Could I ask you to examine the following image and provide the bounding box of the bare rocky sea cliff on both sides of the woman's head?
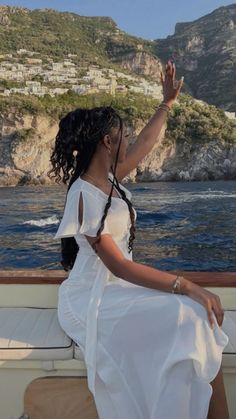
[0,113,236,186]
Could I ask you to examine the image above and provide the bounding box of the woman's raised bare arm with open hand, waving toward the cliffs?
[116,61,183,182]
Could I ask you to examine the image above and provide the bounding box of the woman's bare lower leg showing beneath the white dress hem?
[207,366,230,419]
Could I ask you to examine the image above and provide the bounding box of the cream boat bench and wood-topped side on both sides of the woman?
[0,270,236,419]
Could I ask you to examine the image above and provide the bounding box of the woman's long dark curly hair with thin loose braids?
[47,106,135,271]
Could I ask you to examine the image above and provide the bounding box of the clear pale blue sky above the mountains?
[0,0,234,39]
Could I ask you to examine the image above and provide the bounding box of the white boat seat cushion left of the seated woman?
[0,307,73,360]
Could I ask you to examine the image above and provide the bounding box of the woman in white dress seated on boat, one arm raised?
[48,61,229,419]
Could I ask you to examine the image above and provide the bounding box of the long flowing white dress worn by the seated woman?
[54,174,229,419]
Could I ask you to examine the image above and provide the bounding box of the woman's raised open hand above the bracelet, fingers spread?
[160,60,184,105]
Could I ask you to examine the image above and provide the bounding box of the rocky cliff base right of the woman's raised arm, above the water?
[127,133,236,182]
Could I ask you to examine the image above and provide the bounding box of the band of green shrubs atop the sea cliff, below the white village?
[0,91,236,144]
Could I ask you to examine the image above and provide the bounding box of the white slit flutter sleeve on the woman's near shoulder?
[53,190,110,239]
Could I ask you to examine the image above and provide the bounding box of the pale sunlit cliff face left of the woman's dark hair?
[0,113,58,186]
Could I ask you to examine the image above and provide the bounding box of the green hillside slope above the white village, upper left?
[0,6,153,66]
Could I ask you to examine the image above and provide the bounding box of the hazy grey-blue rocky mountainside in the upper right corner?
[154,4,236,112]
